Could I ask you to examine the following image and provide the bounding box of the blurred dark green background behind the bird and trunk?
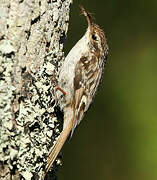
[58,0,157,180]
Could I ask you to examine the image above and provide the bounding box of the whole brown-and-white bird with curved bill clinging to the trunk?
[44,7,108,178]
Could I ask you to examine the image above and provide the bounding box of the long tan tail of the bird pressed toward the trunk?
[43,121,72,177]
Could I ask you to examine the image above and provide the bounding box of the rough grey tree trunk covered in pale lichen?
[0,0,71,180]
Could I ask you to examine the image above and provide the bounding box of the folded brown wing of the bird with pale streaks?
[71,56,103,136]
